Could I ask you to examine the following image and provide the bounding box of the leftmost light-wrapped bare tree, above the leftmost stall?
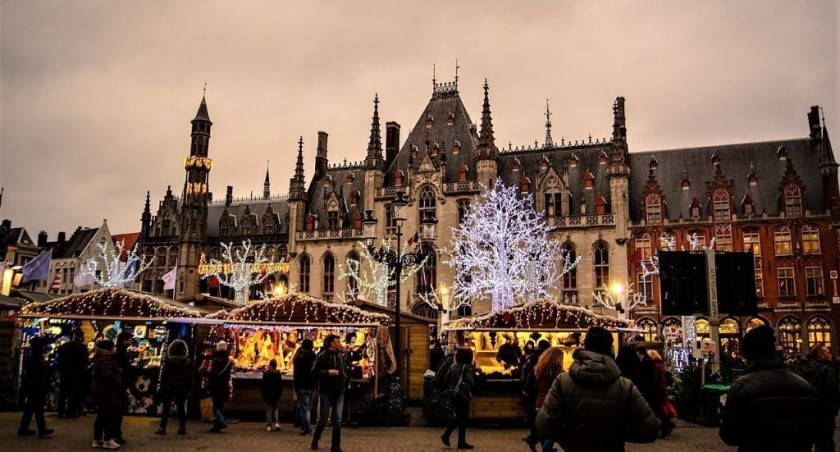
[76,240,152,288]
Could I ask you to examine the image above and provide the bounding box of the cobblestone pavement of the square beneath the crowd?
[0,412,840,452]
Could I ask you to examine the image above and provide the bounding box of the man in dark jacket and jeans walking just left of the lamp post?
[310,334,348,452]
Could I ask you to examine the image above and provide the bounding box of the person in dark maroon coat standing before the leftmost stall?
[90,340,123,450]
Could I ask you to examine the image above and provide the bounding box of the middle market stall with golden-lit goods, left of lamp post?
[203,294,393,412]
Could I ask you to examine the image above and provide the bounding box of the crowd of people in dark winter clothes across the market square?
[13,326,840,452]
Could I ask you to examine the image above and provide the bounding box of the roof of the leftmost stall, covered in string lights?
[21,288,201,319]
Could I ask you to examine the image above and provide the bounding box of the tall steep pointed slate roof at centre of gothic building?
[385,84,478,186]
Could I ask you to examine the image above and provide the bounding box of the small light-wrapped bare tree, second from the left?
[201,240,270,305]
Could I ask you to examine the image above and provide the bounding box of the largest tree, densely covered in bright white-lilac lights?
[444,183,580,312]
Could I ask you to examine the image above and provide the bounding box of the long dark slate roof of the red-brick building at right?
[630,138,825,222]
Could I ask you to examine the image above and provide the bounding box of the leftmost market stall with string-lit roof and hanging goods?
[15,288,207,415]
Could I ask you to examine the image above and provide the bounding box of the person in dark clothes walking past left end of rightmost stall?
[440,347,475,449]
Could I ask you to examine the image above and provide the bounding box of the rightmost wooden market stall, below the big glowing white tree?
[444,299,631,420]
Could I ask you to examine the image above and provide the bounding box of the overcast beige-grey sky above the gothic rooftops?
[0,0,840,240]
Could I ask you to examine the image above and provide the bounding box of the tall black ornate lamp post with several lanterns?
[362,191,437,380]
